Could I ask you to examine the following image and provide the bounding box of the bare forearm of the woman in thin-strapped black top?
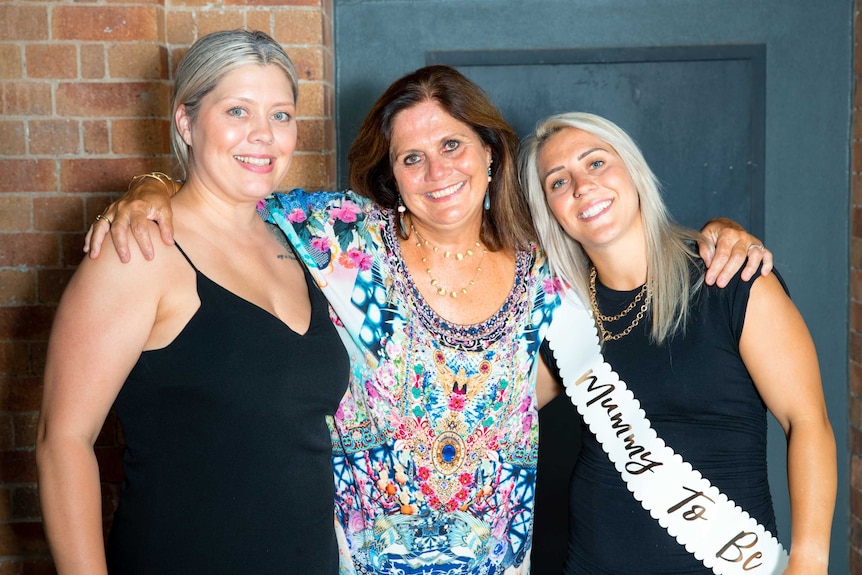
[37,438,108,575]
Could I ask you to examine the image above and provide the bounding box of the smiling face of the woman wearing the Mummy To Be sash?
[537,128,643,256]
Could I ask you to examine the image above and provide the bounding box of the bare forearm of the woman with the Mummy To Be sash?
[787,414,837,574]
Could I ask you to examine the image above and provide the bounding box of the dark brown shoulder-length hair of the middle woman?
[347,65,537,251]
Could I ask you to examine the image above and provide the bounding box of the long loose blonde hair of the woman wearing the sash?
[519,112,703,344]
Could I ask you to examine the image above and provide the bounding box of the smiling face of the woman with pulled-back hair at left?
[176,64,296,198]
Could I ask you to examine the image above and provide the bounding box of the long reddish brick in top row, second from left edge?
[51,4,160,42]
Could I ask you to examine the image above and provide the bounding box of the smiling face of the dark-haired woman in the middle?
[389,101,491,235]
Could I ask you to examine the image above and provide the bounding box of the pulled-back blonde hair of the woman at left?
[171,30,299,179]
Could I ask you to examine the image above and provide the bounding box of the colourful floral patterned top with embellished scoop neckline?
[261,190,560,575]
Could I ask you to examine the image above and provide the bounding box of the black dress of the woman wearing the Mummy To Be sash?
[543,264,776,575]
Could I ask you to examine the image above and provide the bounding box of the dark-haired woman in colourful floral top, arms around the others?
[81,66,768,575]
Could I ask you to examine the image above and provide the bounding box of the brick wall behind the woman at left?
[0,0,335,575]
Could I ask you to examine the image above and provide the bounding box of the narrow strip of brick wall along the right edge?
[852,5,862,575]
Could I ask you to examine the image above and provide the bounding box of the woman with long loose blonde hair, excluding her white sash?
[521,113,836,575]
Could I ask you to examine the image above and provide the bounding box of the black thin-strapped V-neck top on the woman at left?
[108,246,349,575]
